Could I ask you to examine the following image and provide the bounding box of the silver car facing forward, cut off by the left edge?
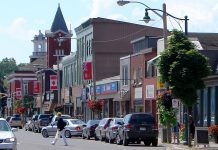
[0,118,18,150]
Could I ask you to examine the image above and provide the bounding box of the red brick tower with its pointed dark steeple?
[45,4,72,68]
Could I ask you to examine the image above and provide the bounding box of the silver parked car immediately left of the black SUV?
[105,118,123,143]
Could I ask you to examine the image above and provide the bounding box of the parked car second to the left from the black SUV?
[95,118,112,141]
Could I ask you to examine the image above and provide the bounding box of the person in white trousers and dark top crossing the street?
[51,112,68,146]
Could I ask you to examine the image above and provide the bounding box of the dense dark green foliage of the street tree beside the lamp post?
[158,30,211,106]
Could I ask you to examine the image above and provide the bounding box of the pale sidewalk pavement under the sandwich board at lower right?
[158,138,218,150]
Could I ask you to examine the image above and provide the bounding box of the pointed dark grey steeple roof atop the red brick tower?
[51,4,69,33]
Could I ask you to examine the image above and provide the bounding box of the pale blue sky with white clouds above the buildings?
[0,0,218,64]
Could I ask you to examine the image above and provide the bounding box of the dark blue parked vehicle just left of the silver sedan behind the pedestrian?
[34,114,50,133]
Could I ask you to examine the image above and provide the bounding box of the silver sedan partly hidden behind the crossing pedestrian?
[42,119,85,138]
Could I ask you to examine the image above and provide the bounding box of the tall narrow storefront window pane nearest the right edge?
[210,87,215,125]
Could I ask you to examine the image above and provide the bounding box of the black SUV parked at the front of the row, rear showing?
[116,113,158,146]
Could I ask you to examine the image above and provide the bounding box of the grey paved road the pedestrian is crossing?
[15,129,168,150]
